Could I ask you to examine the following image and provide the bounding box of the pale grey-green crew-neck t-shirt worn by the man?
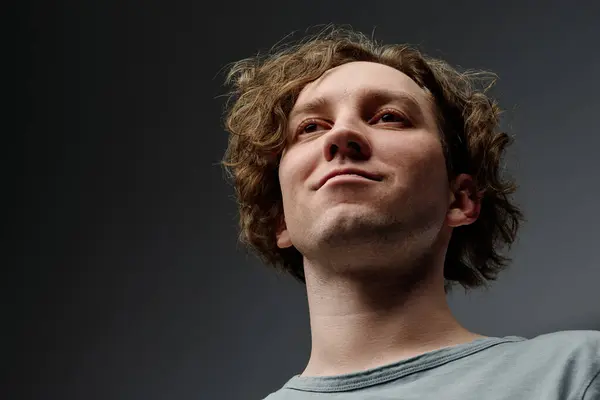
[265,331,600,400]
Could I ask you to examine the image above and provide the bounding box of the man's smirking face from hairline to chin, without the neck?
[278,62,450,272]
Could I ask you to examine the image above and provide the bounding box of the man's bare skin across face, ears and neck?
[277,62,483,376]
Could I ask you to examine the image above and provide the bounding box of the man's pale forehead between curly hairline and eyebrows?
[292,61,430,114]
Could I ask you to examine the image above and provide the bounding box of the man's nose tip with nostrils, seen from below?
[323,127,371,161]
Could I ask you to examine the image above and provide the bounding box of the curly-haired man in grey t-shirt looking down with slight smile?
[224,29,600,400]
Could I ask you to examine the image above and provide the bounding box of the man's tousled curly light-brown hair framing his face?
[222,26,523,292]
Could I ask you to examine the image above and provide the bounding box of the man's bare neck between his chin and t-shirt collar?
[302,260,484,376]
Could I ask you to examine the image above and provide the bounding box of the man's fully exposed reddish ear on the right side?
[446,174,483,228]
